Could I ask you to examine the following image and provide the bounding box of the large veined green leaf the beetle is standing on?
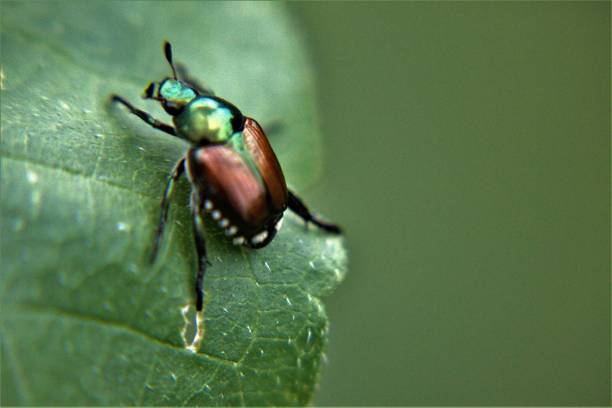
[0,2,346,405]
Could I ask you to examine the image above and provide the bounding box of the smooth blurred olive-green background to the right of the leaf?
[289,2,610,405]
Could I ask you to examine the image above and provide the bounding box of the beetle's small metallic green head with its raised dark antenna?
[142,41,198,116]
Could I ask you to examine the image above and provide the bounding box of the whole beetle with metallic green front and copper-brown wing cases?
[111,41,341,312]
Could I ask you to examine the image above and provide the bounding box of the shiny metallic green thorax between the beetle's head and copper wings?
[174,96,240,143]
